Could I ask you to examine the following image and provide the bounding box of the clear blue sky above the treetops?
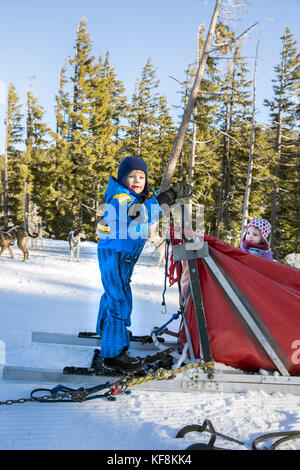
[0,0,300,152]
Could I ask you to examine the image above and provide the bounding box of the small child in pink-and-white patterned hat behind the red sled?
[241,217,273,260]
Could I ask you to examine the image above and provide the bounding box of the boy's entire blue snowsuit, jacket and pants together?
[96,177,162,358]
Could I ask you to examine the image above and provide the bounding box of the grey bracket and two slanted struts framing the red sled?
[173,241,290,377]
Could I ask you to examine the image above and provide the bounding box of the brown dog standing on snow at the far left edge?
[0,225,38,261]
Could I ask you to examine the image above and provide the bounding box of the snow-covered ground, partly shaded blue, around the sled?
[0,240,300,450]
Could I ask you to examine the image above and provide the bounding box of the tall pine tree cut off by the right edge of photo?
[265,28,300,260]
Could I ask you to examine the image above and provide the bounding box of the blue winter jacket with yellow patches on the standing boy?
[97,176,162,253]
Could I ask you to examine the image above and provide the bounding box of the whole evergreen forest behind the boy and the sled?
[0,18,300,260]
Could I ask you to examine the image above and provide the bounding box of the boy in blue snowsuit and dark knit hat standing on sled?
[96,157,192,372]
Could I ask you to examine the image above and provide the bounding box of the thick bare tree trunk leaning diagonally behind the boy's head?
[160,0,222,191]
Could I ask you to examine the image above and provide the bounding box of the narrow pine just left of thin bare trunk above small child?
[213,44,251,243]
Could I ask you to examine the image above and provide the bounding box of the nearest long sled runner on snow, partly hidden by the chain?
[3,366,300,395]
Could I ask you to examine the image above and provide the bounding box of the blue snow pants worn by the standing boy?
[96,245,138,357]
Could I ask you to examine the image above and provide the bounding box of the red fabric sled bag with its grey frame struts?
[175,235,300,376]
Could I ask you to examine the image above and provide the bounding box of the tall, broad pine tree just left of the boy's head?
[52,18,127,237]
